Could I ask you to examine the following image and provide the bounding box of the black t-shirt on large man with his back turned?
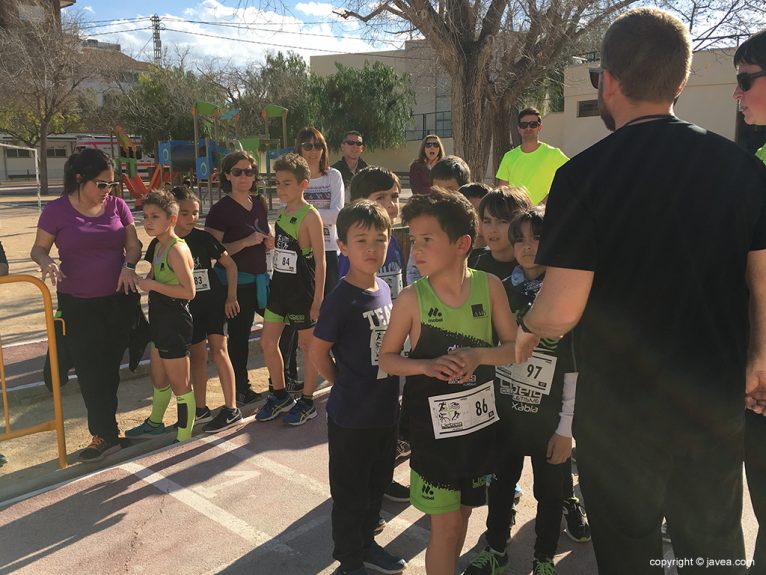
[537,117,766,445]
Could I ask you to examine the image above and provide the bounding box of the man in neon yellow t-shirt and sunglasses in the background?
[495,108,569,205]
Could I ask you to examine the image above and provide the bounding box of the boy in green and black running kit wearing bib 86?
[380,190,515,575]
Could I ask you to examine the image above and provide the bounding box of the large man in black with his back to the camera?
[516,8,766,575]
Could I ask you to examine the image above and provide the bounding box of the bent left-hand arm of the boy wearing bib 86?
[378,287,460,381]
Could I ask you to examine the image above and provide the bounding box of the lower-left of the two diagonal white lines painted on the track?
[119,462,296,555]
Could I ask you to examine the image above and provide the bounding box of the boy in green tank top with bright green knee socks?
[130,191,196,441]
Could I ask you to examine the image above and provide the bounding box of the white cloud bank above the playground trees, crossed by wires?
[83,0,395,66]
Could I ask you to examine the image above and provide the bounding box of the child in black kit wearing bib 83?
[140,186,242,435]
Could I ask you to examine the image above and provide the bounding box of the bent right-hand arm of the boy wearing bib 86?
[450,274,516,383]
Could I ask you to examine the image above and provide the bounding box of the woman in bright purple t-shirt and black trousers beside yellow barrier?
[31,148,141,461]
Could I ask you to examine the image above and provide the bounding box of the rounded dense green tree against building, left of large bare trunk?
[318,62,415,150]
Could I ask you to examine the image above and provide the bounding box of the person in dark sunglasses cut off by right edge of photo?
[733,30,766,575]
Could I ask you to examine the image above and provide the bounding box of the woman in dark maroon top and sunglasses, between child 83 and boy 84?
[205,151,274,407]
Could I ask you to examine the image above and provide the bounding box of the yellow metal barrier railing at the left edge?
[0,275,67,469]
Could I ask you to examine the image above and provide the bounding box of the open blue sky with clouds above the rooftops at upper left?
[67,0,400,66]
